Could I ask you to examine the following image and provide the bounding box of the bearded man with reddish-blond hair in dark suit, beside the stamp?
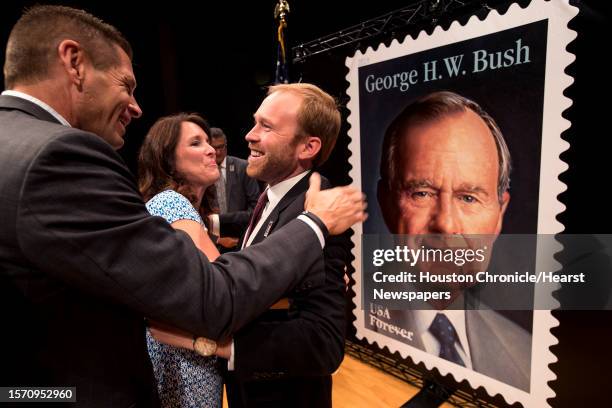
[220,83,350,408]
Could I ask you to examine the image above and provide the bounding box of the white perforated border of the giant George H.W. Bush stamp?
[346,0,578,407]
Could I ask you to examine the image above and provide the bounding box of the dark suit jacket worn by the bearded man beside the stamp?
[227,176,350,408]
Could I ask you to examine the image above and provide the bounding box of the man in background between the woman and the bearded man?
[210,128,260,252]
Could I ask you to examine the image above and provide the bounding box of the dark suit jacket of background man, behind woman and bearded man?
[219,156,260,237]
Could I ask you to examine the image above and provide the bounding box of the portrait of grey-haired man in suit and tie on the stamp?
[378,92,531,390]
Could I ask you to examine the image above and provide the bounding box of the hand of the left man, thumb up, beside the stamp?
[304,173,368,235]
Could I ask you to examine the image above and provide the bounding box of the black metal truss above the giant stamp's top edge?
[292,0,482,63]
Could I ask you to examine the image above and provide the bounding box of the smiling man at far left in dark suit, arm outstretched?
[0,6,364,407]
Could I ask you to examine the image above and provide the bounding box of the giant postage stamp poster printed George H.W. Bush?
[347,0,577,407]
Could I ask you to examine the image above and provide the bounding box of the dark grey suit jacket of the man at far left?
[0,96,324,407]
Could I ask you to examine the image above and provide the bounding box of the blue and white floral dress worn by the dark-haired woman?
[146,190,223,408]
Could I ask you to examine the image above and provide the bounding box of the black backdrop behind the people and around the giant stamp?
[0,0,612,407]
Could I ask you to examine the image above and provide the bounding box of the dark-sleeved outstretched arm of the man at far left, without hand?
[16,135,322,339]
